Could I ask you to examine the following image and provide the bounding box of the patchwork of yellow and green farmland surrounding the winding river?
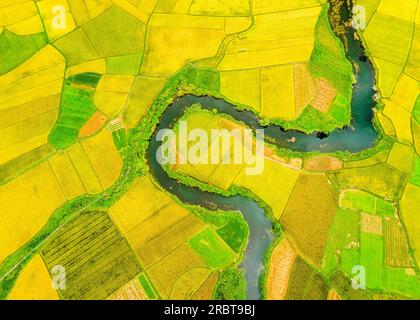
[0,0,420,300]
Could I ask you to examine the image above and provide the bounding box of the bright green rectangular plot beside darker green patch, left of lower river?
[189,228,234,269]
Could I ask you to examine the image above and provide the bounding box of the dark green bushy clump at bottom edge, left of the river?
[213,268,246,300]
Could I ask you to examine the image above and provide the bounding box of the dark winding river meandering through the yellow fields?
[147,2,377,300]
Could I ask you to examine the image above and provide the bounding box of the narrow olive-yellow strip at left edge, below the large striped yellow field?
[0,144,55,183]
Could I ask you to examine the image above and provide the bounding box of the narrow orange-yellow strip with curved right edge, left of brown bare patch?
[294,63,316,116]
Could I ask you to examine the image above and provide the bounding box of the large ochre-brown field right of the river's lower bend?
[280,174,337,266]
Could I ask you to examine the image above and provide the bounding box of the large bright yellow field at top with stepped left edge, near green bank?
[219,6,321,71]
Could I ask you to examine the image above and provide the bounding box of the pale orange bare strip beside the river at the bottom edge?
[267,238,296,300]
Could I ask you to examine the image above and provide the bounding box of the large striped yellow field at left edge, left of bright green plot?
[0,46,65,164]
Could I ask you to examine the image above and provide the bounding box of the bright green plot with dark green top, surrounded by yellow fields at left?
[49,73,101,149]
